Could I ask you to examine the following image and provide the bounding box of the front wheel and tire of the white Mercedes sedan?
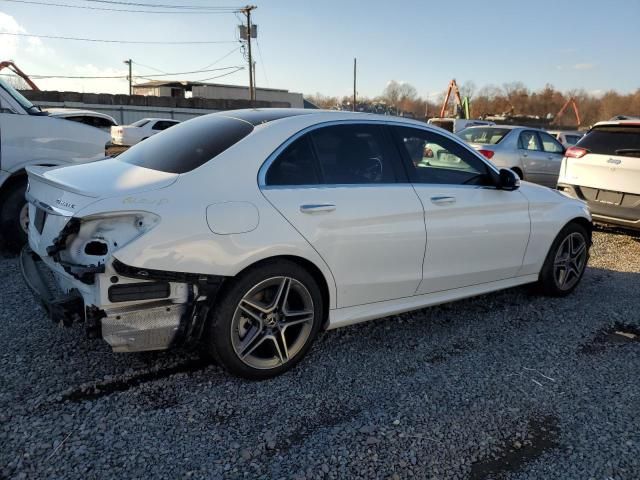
[537,223,591,297]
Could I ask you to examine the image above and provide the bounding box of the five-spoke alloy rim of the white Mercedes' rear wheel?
[231,276,315,369]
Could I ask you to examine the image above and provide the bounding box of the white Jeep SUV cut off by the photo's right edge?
[558,120,640,230]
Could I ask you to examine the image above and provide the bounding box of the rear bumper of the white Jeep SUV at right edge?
[557,183,640,230]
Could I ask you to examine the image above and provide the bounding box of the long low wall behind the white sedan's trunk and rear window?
[21,90,291,125]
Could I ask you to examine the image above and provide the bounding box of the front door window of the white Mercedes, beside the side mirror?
[392,127,492,185]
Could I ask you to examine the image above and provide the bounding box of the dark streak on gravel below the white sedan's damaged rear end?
[61,358,212,402]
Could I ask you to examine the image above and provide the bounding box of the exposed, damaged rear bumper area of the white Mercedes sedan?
[20,246,223,352]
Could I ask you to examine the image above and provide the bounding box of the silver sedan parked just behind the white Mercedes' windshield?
[458,125,565,188]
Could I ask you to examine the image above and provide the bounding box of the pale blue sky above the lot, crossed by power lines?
[0,0,640,98]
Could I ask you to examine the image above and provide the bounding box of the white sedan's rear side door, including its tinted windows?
[260,123,425,308]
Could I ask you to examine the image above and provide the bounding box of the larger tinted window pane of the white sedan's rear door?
[310,124,400,185]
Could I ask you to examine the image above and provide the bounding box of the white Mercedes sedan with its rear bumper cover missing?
[21,109,591,378]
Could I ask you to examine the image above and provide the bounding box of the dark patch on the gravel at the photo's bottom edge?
[469,415,560,480]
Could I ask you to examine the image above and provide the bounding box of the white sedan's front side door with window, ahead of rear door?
[392,126,530,294]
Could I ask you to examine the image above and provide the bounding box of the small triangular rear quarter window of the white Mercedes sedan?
[265,134,319,185]
